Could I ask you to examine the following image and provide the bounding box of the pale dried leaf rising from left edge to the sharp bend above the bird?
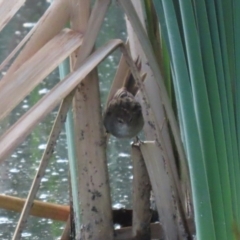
[0,40,123,163]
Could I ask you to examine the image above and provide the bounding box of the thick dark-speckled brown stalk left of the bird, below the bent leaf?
[73,71,113,240]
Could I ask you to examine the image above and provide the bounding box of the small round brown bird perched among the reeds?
[103,87,144,138]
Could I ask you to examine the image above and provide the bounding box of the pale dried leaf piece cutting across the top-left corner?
[0,0,25,31]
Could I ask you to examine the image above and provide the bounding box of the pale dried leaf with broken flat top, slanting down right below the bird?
[140,142,181,239]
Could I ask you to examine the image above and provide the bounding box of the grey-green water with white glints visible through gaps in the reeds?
[0,0,132,240]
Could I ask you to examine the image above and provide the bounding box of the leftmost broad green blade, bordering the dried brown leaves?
[154,0,216,239]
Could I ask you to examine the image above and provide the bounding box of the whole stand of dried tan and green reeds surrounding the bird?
[0,0,240,240]
